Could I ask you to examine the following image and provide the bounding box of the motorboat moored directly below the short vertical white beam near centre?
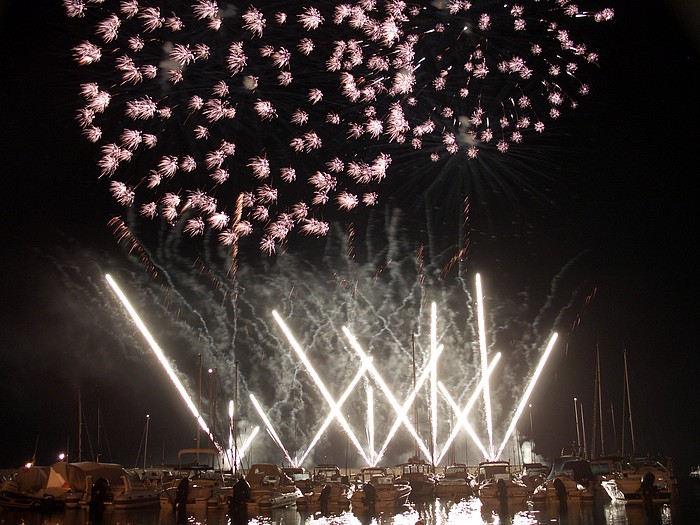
[350,467,411,513]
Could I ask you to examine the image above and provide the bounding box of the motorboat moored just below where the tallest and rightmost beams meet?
[475,461,527,506]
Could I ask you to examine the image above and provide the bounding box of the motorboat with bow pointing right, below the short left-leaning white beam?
[245,463,302,515]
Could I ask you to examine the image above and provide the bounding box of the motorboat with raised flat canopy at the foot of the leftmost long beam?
[160,448,233,509]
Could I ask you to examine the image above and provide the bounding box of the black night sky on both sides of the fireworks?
[0,0,700,475]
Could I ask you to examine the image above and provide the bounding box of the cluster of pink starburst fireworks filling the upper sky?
[64,0,612,253]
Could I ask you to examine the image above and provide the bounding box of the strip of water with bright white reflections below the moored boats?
[0,499,685,525]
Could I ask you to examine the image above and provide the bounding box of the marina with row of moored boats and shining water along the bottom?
[0,458,700,525]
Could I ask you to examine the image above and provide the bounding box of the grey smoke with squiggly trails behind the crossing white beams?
[94,207,584,462]
